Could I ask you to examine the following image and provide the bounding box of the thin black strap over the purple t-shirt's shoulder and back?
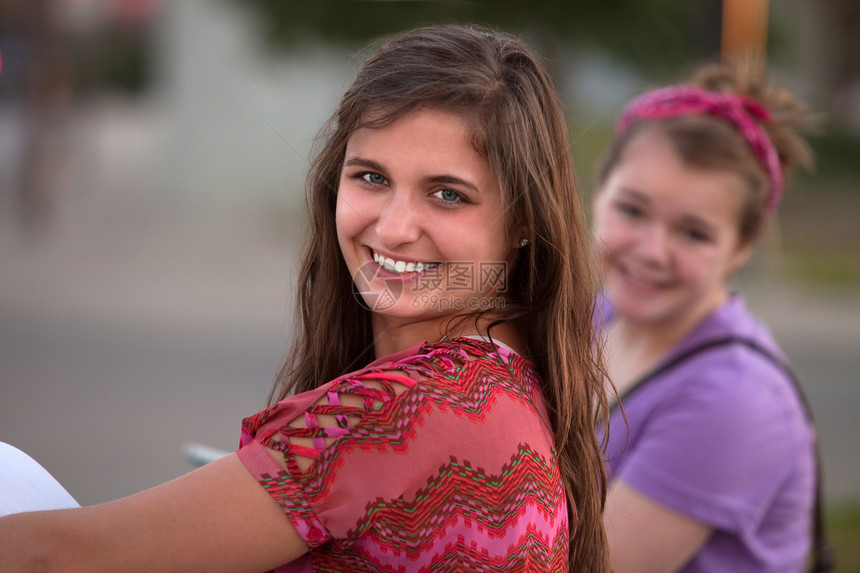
[612,336,836,573]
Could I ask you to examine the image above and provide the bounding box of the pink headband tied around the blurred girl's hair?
[615,86,782,210]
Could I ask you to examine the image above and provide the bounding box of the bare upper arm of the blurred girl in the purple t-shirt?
[604,480,712,573]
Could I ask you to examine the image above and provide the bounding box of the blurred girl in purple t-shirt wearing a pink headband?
[594,64,818,573]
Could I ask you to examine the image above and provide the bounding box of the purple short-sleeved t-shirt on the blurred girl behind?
[604,295,815,573]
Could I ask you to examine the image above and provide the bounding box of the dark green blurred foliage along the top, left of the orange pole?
[234,0,720,73]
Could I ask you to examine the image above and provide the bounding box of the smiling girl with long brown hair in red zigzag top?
[0,26,609,572]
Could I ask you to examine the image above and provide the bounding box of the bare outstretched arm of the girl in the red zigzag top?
[0,454,308,573]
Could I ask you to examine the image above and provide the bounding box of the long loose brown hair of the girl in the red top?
[272,26,609,572]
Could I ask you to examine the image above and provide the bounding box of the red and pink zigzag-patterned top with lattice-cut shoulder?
[238,338,568,572]
